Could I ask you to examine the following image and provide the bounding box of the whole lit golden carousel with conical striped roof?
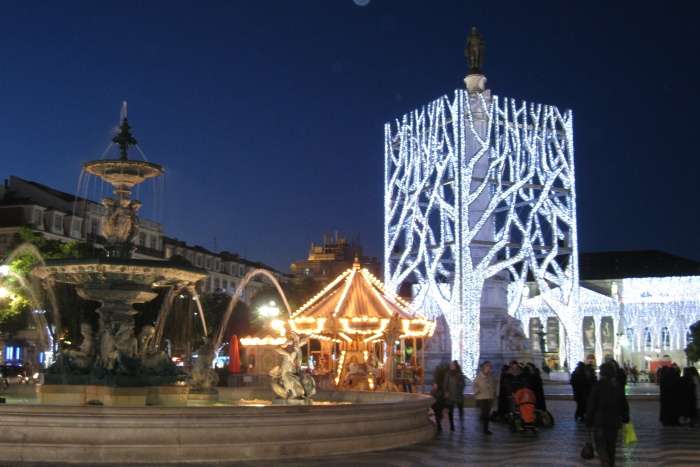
[287,261,435,391]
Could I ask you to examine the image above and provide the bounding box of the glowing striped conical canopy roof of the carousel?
[289,262,434,335]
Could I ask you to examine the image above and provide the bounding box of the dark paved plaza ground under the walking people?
[235,400,700,467]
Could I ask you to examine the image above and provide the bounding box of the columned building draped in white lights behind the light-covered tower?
[515,251,700,370]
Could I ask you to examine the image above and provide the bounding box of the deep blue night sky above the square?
[0,0,700,271]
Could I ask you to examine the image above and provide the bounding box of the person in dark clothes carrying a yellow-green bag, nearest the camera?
[586,362,630,467]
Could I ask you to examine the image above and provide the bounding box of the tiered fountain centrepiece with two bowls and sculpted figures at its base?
[32,110,206,405]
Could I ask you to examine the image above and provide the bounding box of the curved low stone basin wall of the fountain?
[0,388,434,465]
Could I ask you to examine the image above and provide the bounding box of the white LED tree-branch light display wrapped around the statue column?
[384,90,580,377]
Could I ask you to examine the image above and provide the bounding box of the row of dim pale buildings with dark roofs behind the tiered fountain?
[0,176,287,364]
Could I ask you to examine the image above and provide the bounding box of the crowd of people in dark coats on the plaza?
[431,355,700,466]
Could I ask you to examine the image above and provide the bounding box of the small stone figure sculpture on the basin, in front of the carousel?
[270,333,316,404]
